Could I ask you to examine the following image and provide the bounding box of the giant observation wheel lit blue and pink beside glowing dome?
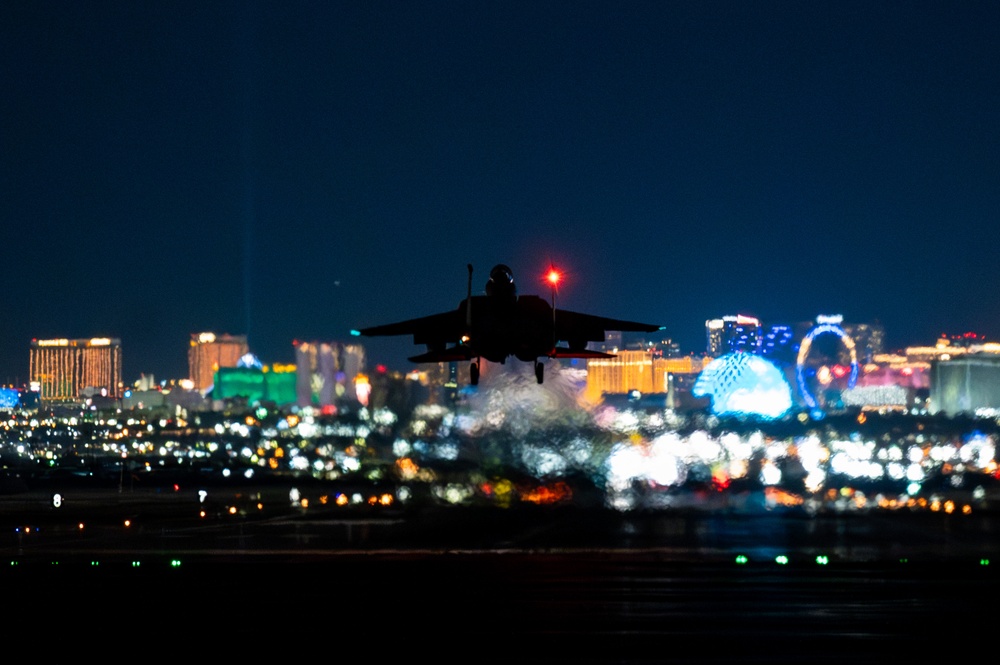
[795,323,858,409]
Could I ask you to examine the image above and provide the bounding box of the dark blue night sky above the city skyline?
[0,0,1000,382]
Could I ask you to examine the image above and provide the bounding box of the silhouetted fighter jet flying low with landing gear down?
[351,264,663,385]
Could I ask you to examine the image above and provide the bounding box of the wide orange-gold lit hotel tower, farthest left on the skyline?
[28,337,122,401]
